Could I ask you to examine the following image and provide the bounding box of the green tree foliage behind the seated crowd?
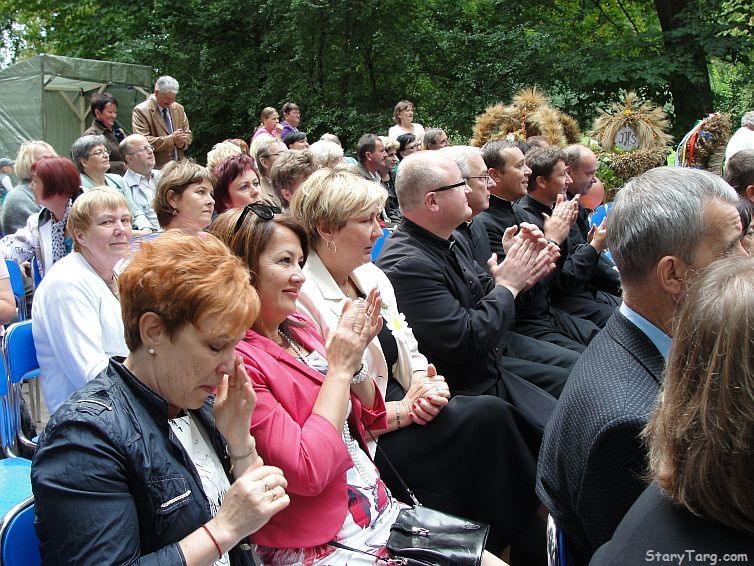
[0,0,754,155]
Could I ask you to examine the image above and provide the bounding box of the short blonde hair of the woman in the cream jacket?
[290,166,387,245]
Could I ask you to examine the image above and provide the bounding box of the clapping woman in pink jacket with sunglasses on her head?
[211,203,501,565]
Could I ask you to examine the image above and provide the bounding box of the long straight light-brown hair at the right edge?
[644,257,754,535]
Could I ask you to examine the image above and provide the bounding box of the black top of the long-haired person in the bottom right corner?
[589,484,754,566]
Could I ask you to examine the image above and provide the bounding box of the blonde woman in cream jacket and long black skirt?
[291,168,538,554]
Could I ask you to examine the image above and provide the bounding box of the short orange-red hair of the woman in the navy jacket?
[118,230,259,352]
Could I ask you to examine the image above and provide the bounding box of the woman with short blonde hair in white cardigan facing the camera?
[32,187,132,414]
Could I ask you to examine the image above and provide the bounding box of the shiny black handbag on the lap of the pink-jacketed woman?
[330,433,490,566]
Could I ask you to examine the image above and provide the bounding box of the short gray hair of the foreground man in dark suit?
[607,167,738,283]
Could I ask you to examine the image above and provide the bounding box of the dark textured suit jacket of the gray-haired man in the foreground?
[536,311,665,564]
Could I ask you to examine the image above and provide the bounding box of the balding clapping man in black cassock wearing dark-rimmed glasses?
[377,152,555,431]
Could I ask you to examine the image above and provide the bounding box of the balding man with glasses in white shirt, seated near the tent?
[120,134,160,231]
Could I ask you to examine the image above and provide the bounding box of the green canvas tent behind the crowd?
[0,55,153,159]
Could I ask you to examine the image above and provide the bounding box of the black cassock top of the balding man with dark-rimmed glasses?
[377,218,515,395]
